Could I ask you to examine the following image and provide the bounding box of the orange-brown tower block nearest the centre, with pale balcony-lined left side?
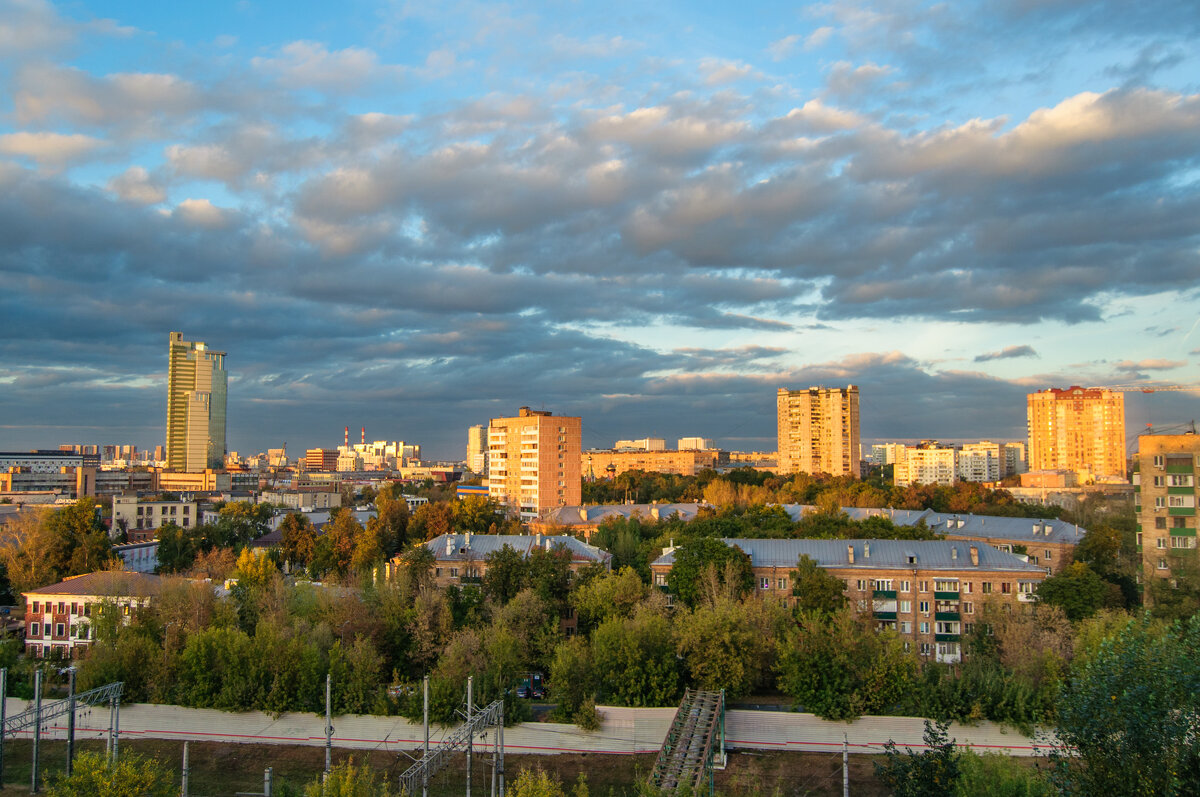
[487,407,583,521]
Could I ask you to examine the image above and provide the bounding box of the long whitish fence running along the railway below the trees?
[0,699,1046,756]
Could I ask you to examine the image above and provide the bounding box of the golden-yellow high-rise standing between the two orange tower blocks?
[776,385,862,477]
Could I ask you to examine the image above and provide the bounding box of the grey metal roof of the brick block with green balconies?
[654,539,1045,576]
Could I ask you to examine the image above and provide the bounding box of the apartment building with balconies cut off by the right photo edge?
[1134,435,1200,580]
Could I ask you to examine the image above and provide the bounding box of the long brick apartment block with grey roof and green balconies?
[650,539,1046,663]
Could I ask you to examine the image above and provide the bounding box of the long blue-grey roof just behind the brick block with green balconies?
[782,504,1087,543]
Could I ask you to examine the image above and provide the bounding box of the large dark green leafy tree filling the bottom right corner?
[1052,616,1200,797]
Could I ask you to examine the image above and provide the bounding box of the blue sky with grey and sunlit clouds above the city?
[0,0,1200,459]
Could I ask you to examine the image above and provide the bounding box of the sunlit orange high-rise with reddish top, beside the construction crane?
[1028,386,1126,483]
